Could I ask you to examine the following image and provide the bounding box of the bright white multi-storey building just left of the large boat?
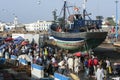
[25,20,52,31]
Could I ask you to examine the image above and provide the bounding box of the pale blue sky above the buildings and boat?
[0,0,120,23]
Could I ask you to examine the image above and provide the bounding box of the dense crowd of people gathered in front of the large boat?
[0,36,115,80]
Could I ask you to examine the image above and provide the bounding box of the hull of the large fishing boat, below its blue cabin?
[51,30,107,49]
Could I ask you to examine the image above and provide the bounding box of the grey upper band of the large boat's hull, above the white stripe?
[51,30,107,39]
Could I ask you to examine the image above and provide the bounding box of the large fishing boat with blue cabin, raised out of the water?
[50,0,107,50]
